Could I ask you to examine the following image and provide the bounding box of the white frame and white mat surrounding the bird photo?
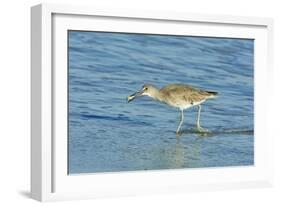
[31,4,273,201]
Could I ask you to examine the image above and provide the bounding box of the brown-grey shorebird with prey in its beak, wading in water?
[127,84,218,134]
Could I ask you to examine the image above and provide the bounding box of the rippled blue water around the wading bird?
[68,31,254,174]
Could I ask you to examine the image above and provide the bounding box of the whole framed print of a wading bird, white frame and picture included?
[31,4,273,201]
